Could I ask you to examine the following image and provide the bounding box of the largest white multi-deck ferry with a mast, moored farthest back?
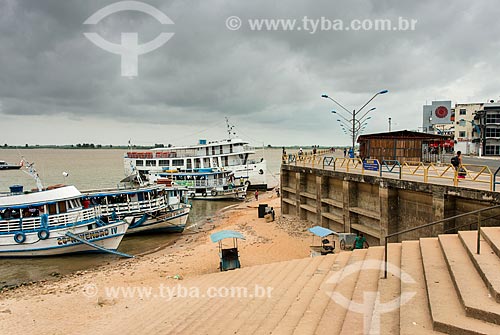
[124,124,267,189]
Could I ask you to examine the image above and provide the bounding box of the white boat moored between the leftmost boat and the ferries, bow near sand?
[83,185,191,234]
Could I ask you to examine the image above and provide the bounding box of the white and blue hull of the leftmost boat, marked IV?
[0,221,128,257]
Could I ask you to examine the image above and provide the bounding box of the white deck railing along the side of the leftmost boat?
[0,207,101,233]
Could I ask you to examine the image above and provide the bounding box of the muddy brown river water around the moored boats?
[0,149,281,288]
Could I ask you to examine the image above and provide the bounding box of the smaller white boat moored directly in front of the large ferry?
[149,169,248,200]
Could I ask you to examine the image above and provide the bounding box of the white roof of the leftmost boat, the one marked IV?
[0,186,82,208]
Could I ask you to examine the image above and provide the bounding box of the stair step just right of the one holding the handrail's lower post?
[399,241,441,335]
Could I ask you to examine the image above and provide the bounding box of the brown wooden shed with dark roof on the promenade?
[358,130,453,163]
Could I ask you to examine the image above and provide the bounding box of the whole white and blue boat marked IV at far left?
[0,186,128,257]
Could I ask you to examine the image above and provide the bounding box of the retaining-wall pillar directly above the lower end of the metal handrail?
[379,182,400,245]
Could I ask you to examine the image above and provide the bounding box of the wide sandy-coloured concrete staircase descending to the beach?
[95,228,500,335]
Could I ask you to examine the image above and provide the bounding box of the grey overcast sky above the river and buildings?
[0,0,500,145]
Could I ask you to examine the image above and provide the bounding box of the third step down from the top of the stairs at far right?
[439,235,500,324]
